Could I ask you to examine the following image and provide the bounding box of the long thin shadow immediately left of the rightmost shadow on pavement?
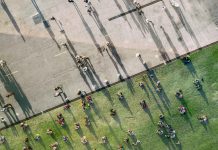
[164,4,189,53]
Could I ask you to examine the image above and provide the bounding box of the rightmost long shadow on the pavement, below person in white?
[173,7,201,48]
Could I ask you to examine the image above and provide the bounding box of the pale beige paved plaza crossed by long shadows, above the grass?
[0,0,218,127]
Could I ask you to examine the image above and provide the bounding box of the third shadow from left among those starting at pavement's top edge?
[73,2,103,55]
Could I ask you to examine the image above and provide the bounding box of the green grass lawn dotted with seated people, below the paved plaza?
[0,44,218,150]
